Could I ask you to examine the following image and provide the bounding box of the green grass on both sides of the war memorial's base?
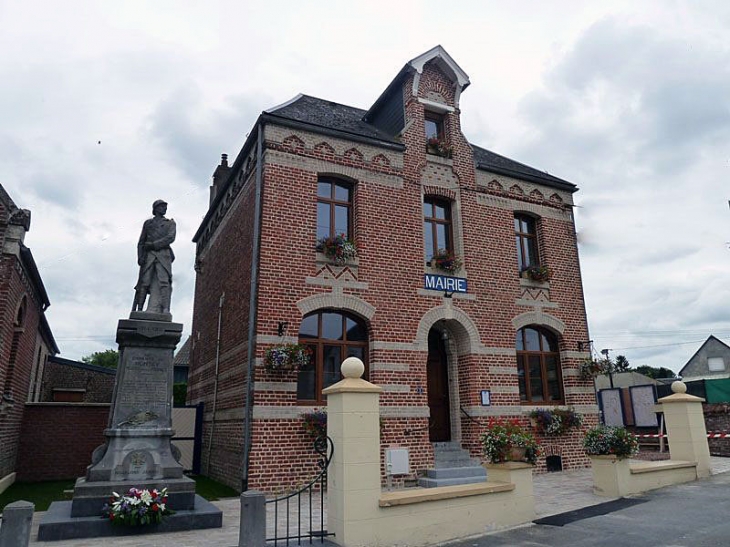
[0,475,238,512]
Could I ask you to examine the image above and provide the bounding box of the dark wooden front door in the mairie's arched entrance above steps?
[426,329,451,442]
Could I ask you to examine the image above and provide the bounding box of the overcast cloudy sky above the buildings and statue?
[0,0,730,371]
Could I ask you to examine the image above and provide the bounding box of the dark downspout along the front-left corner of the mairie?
[241,125,264,492]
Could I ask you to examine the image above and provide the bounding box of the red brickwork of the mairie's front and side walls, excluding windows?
[190,54,596,491]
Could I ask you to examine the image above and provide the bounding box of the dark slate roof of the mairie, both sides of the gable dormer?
[264,95,576,191]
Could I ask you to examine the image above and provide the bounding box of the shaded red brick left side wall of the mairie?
[188,173,255,488]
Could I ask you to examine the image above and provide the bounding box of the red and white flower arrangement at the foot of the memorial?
[103,488,174,526]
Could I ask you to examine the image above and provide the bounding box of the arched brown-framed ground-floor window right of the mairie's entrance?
[515,327,563,403]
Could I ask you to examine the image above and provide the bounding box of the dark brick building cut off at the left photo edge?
[0,185,58,490]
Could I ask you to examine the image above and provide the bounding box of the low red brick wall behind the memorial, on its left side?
[16,403,109,482]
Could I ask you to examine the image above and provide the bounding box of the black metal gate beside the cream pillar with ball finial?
[266,436,335,545]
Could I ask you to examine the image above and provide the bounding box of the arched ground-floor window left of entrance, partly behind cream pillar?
[297,311,368,403]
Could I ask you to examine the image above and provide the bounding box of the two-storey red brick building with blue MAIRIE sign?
[188,46,597,491]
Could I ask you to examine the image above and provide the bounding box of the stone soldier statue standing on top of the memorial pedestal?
[132,199,175,314]
